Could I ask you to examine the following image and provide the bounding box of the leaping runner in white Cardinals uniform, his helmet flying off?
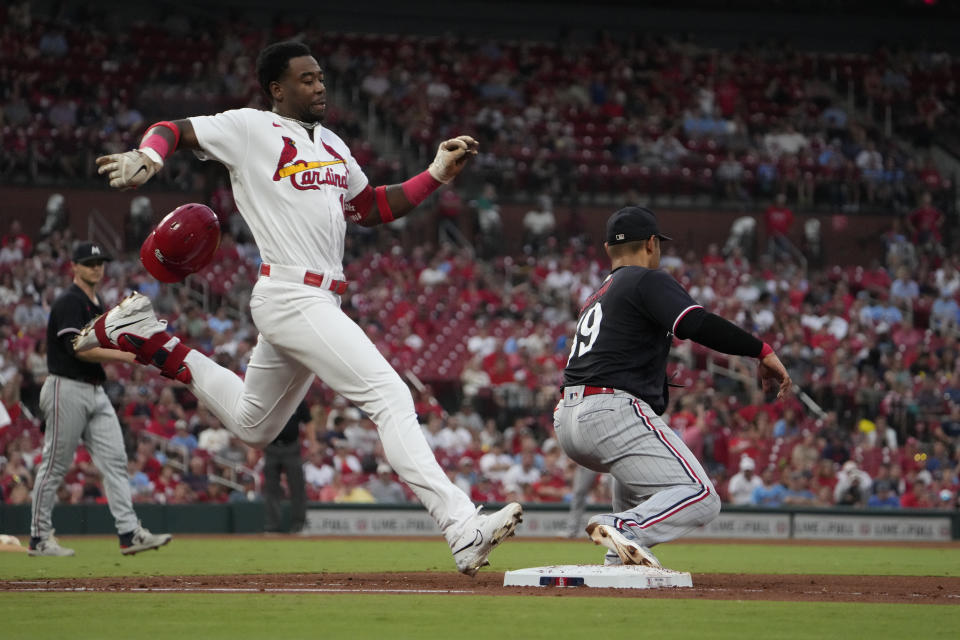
[85,42,522,575]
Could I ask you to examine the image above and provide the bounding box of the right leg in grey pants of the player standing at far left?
[83,387,140,533]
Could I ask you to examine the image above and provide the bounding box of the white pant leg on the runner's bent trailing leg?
[184,335,313,448]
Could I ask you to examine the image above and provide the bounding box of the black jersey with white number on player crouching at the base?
[563,266,701,414]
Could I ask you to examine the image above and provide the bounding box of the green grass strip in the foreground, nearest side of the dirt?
[0,593,960,640]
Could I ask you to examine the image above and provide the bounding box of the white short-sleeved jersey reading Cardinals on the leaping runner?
[190,109,368,279]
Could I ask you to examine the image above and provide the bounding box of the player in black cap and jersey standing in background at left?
[29,242,171,556]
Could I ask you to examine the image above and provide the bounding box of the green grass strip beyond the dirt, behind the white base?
[0,536,960,580]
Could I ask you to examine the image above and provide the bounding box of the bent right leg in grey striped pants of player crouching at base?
[607,399,720,547]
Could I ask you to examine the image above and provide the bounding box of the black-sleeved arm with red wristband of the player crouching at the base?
[674,309,793,399]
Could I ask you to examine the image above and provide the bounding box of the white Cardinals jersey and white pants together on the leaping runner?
[177,109,483,550]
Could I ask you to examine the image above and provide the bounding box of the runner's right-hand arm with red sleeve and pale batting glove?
[344,136,479,227]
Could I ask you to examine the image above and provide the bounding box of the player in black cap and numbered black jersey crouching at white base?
[554,207,792,567]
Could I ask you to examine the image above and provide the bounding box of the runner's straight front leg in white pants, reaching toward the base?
[253,285,475,542]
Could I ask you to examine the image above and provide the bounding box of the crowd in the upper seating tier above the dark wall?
[0,2,960,213]
